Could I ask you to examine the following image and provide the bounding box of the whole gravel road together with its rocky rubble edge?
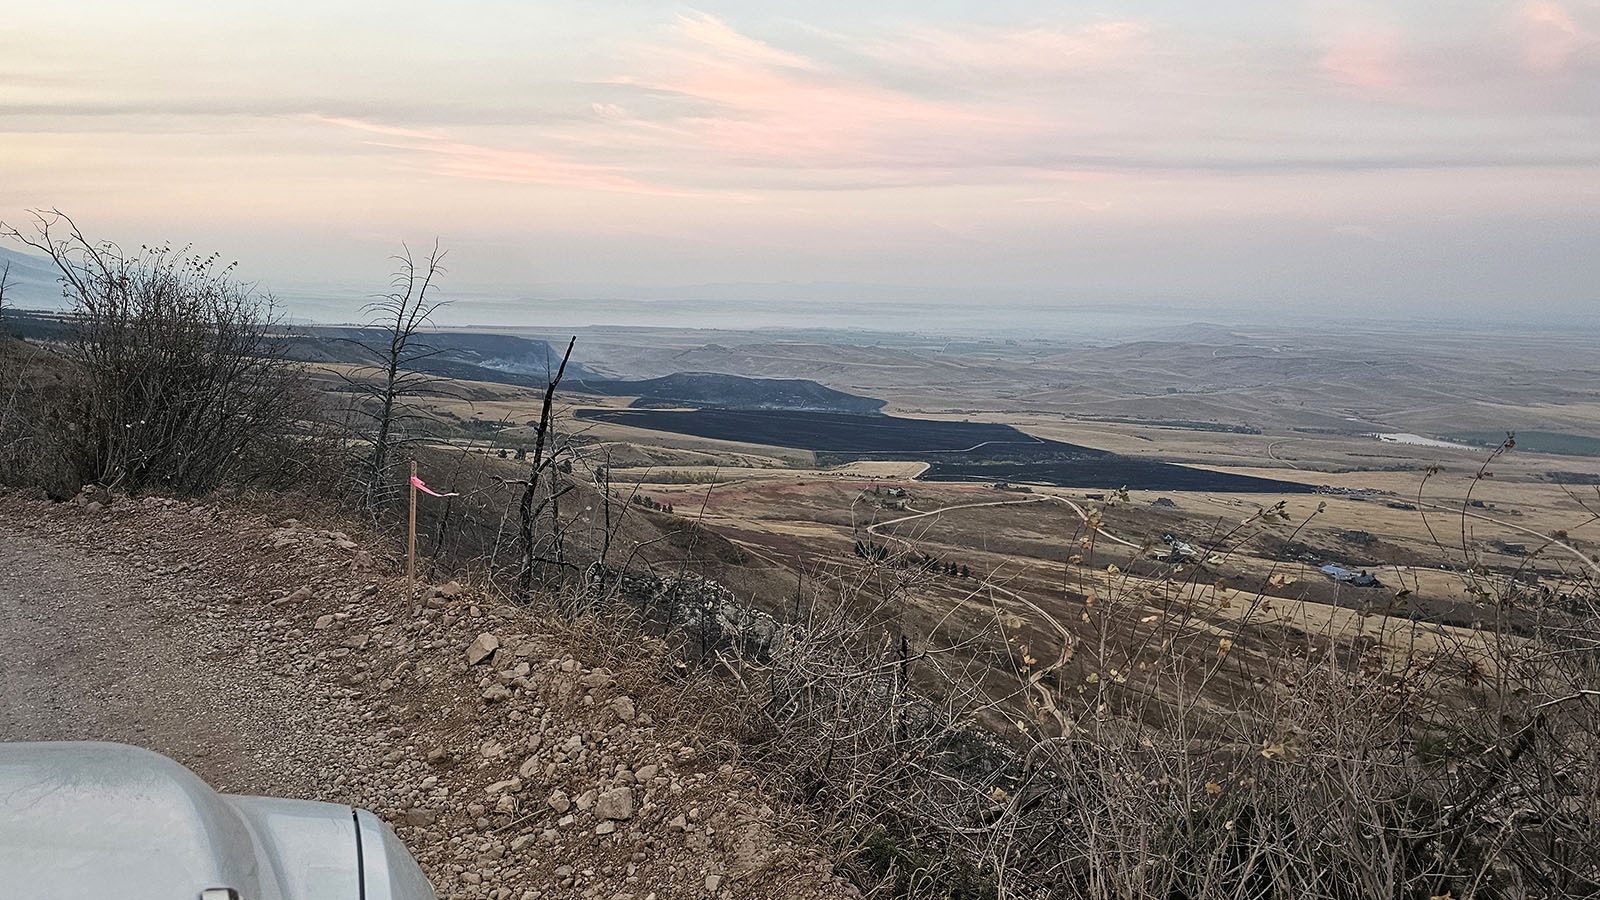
[0,493,854,900]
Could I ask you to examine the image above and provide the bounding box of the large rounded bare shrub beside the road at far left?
[0,211,323,495]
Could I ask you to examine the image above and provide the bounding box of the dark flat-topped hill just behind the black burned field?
[570,372,883,415]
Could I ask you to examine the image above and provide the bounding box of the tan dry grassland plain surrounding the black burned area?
[366,321,1600,736]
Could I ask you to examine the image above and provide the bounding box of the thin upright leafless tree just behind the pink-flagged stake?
[341,242,445,509]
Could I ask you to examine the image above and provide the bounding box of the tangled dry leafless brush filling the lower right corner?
[700,490,1600,900]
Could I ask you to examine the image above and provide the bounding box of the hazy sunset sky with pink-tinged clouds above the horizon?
[0,0,1600,323]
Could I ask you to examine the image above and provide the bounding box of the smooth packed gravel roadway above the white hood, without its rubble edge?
[0,520,338,796]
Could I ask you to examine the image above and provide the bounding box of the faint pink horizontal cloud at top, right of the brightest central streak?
[867,21,1150,74]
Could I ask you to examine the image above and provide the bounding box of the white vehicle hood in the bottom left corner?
[0,741,435,900]
